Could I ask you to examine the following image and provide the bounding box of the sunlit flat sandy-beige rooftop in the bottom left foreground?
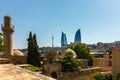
[0,64,55,80]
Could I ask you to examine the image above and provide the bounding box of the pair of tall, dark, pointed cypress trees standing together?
[27,32,40,67]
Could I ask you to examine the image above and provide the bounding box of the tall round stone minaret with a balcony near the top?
[2,16,14,58]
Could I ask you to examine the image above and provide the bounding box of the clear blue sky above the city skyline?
[0,0,120,49]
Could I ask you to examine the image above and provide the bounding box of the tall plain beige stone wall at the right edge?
[112,47,120,75]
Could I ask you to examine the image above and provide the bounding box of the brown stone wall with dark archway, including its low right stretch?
[44,64,101,80]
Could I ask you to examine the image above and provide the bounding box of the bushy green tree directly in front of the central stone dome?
[57,52,81,72]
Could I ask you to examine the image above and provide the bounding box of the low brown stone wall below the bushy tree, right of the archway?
[58,67,101,80]
